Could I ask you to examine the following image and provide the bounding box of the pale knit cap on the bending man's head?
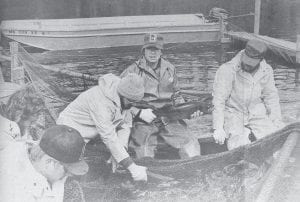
[117,73,145,101]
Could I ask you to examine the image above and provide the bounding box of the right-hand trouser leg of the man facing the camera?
[159,122,200,159]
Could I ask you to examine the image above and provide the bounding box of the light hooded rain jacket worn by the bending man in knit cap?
[57,74,132,162]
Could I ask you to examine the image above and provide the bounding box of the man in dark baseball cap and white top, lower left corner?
[0,125,88,202]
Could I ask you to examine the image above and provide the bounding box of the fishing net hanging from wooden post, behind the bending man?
[18,45,97,121]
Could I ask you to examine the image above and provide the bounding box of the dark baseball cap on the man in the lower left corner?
[39,125,89,175]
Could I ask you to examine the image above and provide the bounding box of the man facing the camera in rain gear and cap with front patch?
[121,33,200,158]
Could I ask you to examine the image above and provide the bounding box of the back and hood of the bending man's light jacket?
[57,74,131,141]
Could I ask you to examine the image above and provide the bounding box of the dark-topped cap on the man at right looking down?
[242,39,267,66]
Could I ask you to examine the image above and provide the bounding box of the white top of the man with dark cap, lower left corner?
[0,141,66,202]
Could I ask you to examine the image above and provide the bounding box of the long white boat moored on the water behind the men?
[0,14,220,50]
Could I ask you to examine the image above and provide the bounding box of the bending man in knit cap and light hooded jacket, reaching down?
[57,74,147,181]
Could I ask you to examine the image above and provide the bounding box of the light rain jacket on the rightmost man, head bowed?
[213,51,282,129]
